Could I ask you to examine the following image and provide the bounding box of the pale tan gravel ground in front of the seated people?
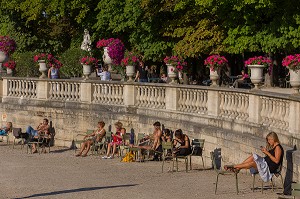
[0,143,281,199]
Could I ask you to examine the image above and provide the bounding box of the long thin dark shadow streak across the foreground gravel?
[14,184,138,199]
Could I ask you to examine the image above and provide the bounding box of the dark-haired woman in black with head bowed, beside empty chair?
[173,129,192,156]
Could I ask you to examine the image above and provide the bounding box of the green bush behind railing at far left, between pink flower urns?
[12,52,40,77]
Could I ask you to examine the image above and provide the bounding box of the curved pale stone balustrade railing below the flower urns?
[2,77,300,138]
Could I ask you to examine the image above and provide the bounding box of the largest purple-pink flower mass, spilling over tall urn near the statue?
[96,38,125,65]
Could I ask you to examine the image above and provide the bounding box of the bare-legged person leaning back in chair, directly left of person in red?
[76,121,106,157]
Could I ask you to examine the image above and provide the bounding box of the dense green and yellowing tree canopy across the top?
[0,0,300,61]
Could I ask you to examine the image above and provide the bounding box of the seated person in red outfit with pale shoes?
[102,122,126,159]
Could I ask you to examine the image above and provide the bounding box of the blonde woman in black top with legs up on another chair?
[224,132,284,182]
